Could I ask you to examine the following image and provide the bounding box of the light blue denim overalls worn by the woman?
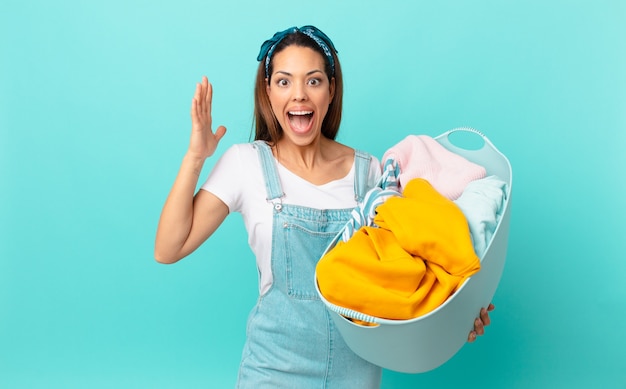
[237,141,382,389]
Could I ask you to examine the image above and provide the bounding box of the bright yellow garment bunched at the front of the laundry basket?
[316,178,480,320]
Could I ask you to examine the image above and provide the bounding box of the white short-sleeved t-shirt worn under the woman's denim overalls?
[201,143,381,294]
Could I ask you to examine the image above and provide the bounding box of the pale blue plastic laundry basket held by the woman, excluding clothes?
[315,128,512,373]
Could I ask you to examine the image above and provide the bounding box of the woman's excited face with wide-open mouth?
[267,45,335,146]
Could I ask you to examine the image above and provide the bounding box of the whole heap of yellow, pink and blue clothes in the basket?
[316,135,506,320]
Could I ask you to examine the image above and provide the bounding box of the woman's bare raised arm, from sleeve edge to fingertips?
[154,77,228,263]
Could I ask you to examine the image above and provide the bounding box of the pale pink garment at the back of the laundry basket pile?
[382,135,487,200]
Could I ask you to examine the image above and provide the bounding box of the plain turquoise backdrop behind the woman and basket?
[0,0,626,388]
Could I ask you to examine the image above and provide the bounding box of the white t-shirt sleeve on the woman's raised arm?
[200,145,247,212]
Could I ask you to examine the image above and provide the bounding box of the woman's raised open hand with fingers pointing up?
[188,77,226,160]
